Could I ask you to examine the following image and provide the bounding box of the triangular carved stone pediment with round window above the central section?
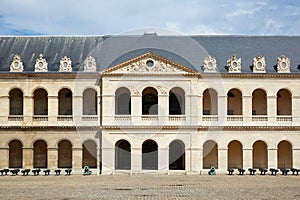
[102,52,198,74]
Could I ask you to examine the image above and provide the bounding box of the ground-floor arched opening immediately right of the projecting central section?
[203,140,218,169]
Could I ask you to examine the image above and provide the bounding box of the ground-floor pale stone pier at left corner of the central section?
[102,147,115,174]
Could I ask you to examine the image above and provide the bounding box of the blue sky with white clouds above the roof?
[0,0,300,35]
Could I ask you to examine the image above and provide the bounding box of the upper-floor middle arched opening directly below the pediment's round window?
[142,87,158,115]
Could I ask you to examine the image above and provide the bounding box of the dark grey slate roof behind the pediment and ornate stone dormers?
[0,34,300,73]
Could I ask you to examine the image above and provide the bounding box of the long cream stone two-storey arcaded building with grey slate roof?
[0,34,300,174]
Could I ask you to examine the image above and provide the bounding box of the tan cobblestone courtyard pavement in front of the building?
[0,174,300,200]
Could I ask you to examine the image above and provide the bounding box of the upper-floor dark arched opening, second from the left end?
[33,89,48,115]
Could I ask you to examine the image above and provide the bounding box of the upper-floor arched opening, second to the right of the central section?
[227,89,243,115]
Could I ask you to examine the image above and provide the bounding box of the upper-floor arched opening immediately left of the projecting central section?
[82,88,98,115]
